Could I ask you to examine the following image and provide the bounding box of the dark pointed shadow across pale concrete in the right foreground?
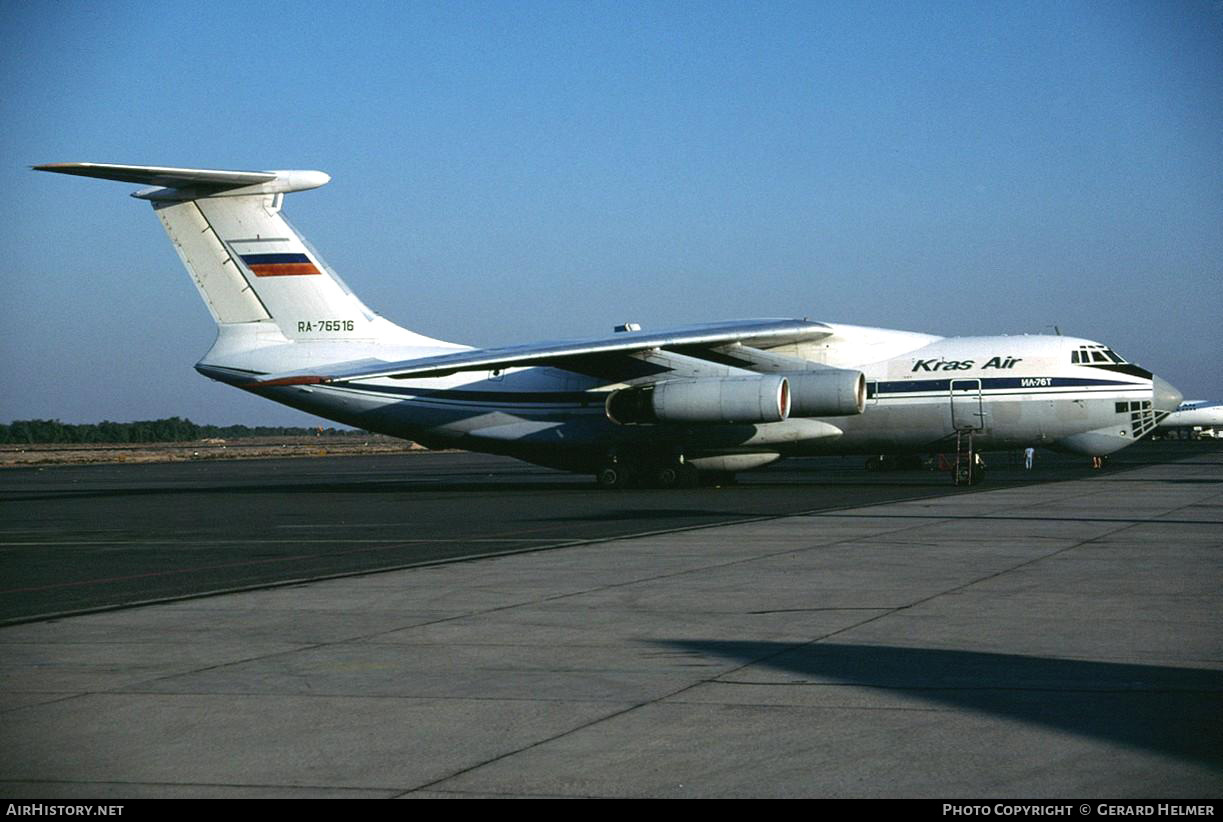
[662,640,1223,769]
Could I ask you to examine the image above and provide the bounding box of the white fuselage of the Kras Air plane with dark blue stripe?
[198,324,1174,470]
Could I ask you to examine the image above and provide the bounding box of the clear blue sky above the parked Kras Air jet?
[0,0,1223,424]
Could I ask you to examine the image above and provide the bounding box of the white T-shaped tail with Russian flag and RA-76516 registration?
[34,163,438,344]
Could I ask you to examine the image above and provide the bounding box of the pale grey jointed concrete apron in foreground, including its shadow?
[0,449,1223,798]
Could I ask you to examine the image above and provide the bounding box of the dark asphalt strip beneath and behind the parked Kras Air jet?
[0,443,1186,624]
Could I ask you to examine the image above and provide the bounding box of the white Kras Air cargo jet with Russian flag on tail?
[33,163,1181,487]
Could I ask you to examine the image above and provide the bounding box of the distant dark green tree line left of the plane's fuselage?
[0,417,368,445]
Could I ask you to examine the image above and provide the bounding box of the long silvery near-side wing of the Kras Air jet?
[251,319,832,387]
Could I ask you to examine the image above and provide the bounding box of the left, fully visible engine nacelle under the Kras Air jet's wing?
[607,374,790,426]
